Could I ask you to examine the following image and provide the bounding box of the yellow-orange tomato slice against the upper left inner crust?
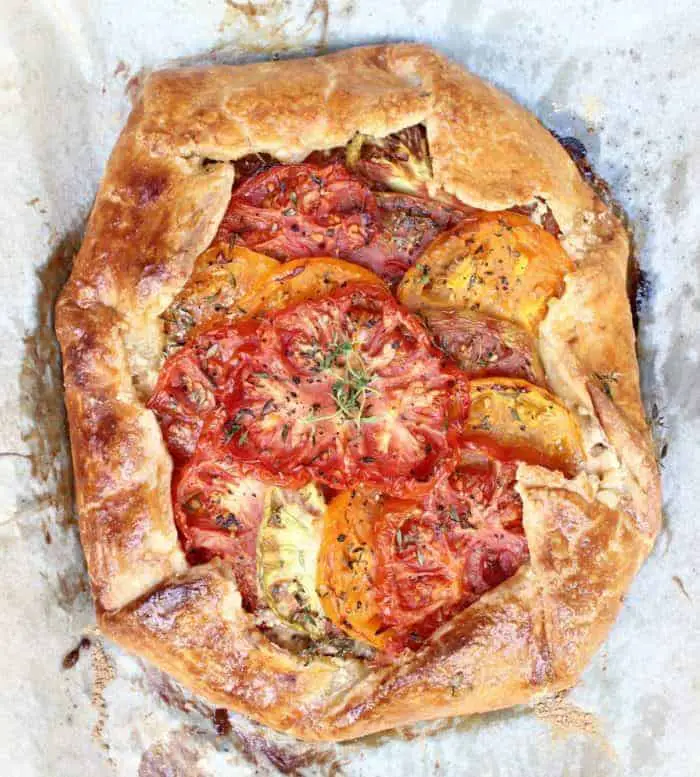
[163,243,279,343]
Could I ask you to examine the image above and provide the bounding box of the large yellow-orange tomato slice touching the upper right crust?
[398,212,574,334]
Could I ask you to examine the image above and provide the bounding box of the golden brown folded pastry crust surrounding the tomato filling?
[57,44,660,739]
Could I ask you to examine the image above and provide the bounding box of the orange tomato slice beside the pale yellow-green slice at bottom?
[317,491,391,649]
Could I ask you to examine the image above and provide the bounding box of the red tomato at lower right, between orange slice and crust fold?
[375,460,527,646]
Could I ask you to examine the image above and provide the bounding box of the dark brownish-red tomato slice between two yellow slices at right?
[421,309,545,385]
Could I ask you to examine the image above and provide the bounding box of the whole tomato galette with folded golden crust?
[56,44,660,740]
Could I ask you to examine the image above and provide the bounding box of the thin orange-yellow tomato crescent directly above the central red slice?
[241,257,385,313]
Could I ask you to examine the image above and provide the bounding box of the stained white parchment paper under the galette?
[0,0,700,777]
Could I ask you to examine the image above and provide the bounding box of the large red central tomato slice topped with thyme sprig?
[154,284,468,493]
